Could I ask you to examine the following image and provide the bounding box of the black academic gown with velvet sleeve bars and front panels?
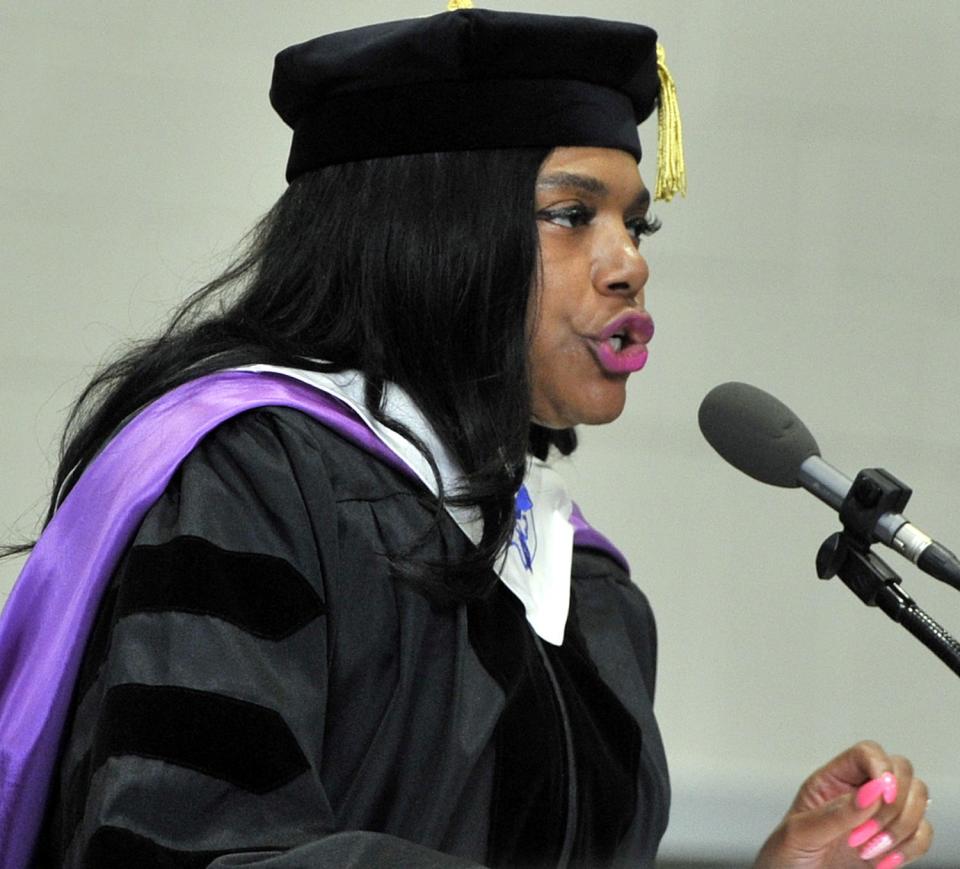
[35,408,669,869]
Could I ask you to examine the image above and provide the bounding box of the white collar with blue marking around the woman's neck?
[237,365,573,646]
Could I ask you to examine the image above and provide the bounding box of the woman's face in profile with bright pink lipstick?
[528,148,655,428]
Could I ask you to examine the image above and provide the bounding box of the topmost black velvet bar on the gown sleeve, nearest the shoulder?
[117,536,324,640]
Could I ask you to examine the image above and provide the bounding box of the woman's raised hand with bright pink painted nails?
[754,742,933,869]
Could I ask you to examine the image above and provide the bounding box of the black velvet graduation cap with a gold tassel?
[270,0,686,199]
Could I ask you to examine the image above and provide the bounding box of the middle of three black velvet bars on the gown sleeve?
[91,684,309,794]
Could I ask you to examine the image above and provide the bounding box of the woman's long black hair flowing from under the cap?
[13,148,576,600]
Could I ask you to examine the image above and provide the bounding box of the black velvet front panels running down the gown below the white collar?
[469,584,642,869]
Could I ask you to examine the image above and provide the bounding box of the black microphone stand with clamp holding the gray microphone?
[817,468,960,676]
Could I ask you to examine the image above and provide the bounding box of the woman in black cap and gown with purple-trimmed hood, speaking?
[0,10,930,869]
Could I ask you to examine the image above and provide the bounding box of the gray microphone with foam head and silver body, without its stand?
[698,382,960,589]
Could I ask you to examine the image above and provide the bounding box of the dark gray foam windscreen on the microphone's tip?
[698,383,820,488]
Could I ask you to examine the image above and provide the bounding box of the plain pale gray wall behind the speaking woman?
[0,0,960,865]
